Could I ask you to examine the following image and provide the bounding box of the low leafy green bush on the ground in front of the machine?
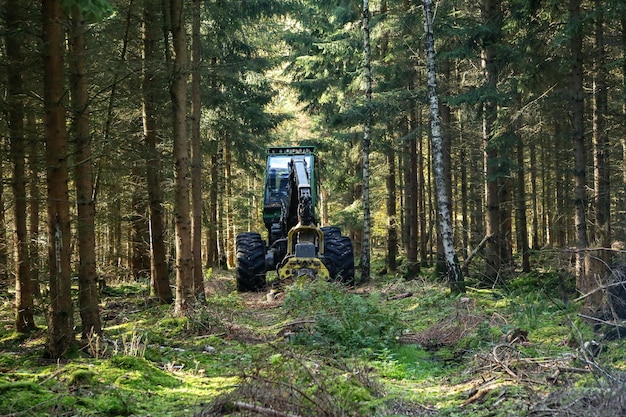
[283,280,402,356]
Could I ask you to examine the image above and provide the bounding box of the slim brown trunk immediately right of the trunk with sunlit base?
[191,0,204,297]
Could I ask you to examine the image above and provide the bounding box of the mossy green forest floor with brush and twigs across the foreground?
[0,264,626,417]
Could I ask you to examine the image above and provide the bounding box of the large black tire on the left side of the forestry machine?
[236,232,267,292]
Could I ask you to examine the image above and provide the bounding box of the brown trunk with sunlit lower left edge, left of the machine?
[170,0,194,315]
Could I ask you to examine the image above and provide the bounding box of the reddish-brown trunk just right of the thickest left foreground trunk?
[70,7,102,339]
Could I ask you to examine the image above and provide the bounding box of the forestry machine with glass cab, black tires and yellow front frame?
[236,146,354,291]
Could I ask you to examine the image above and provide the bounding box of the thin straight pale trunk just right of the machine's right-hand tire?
[361,0,372,281]
